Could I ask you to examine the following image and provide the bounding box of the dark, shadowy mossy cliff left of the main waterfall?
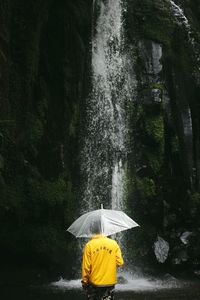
[0,0,91,273]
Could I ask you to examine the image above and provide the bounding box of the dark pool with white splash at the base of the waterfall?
[0,276,200,300]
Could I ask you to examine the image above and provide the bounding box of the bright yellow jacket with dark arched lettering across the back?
[82,235,124,286]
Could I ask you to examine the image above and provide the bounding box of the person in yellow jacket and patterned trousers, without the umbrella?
[81,224,124,300]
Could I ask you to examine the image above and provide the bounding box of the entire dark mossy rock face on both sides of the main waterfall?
[0,0,200,272]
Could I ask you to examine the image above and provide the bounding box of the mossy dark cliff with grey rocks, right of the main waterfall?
[125,0,200,270]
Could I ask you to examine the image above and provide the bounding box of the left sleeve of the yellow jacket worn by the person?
[81,244,91,285]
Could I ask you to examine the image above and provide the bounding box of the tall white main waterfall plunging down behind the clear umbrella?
[81,0,132,210]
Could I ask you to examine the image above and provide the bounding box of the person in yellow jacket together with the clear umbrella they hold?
[67,205,139,300]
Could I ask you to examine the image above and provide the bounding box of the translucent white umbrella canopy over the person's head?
[67,208,139,237]
